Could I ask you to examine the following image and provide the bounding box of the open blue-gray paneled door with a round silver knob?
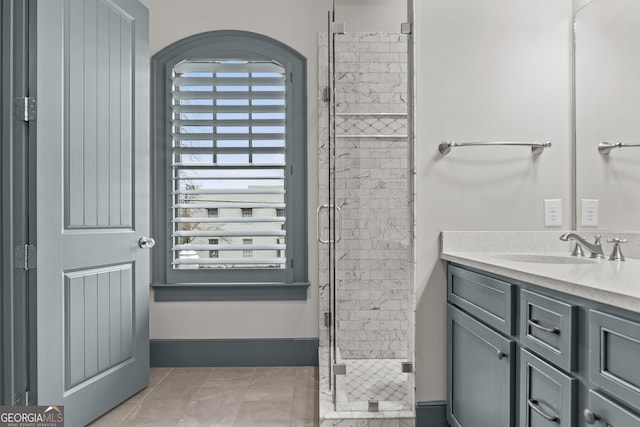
[36,0,150,426]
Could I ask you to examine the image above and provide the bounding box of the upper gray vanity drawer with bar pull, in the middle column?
[520,289,577,371]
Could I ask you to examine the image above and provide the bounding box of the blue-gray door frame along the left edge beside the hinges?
[0,0,36,405]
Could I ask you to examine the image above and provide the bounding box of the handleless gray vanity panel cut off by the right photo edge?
[589,310,640,408]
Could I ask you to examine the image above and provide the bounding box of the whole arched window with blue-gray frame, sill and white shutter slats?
[152,31,308,300]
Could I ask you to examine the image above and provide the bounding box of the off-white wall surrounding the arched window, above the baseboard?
[142,0,331,339]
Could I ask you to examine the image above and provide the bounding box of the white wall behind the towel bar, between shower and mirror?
[414,0,573,401]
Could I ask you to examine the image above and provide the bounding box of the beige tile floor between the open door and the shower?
[89,366,319,427]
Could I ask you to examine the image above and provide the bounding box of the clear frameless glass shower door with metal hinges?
[327,0,414,412]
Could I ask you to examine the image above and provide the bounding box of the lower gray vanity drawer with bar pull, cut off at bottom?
[519,349,577,427]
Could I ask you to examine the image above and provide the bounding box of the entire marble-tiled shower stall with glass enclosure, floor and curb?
[318,0,415,427]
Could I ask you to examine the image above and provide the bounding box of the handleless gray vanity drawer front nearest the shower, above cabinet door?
[447,265,515,335]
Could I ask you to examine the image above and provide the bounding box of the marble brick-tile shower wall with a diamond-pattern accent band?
[319,33,413,359]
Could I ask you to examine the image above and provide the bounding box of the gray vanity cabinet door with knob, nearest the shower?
[447,305,516,427]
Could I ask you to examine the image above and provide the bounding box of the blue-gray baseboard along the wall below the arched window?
[149,338,319,367]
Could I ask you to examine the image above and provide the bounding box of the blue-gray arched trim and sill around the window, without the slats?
[151,30,309,301]
